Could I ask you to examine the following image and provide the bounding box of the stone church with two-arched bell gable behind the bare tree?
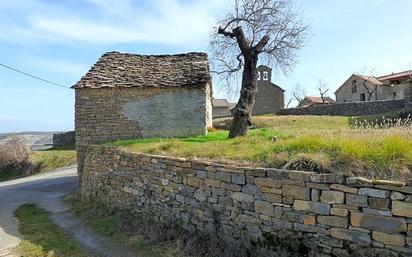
[252,65,285,115]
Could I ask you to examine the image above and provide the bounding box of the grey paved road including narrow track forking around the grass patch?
[0,166,135,257]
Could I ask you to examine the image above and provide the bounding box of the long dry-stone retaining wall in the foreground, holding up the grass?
[80,146,412,257]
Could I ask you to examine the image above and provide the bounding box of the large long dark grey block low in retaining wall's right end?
[350,212,407,234]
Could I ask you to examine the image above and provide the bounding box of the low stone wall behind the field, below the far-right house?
[278,99,405,116]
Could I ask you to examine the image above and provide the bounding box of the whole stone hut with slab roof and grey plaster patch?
[72,52,212,181]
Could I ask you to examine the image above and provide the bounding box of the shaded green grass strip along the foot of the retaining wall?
[68,198,186,257]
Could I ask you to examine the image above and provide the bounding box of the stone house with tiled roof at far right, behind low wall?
[335,70,412,103]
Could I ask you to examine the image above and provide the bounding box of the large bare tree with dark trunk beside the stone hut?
[211,0,307,138]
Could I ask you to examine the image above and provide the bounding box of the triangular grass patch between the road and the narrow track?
[15,204,87,257]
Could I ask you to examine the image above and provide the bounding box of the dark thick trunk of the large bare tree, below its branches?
[229,55,258,138]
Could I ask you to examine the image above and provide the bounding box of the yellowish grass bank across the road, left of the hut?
[0,149,76,182]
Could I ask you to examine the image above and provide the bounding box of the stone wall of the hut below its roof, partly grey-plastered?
[75,85,212,186]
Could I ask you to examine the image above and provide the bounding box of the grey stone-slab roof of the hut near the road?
[72,52,211,89]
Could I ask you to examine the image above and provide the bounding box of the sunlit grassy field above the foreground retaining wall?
[107,115,412,180]
